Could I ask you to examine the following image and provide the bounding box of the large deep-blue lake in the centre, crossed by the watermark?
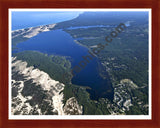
[14,29,113,99]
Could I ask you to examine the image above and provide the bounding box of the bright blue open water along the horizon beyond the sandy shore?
[11,11,82,31]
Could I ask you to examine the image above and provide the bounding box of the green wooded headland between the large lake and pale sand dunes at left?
[13,51,71,84]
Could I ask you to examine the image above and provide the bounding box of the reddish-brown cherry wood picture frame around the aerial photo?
[0,0,160,128]
